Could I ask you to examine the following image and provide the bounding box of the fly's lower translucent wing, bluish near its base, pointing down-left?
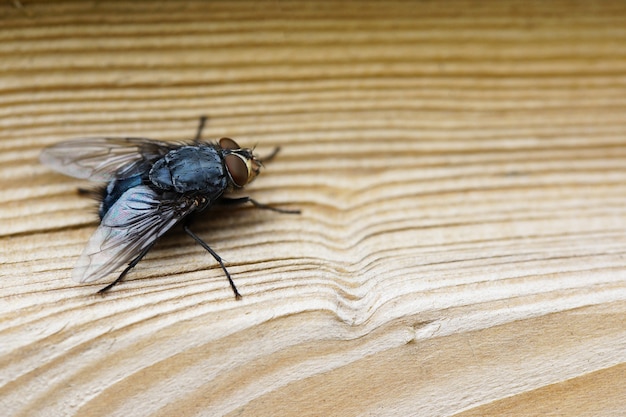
[72,185,196,282]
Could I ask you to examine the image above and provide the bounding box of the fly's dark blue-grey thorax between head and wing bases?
[150,146,228,196]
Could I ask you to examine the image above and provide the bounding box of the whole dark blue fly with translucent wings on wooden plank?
[40,117,299,298]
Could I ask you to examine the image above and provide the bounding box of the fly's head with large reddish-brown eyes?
[218,138,263,188]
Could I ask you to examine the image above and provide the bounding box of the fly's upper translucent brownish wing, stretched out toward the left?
[39,138,178,181]
